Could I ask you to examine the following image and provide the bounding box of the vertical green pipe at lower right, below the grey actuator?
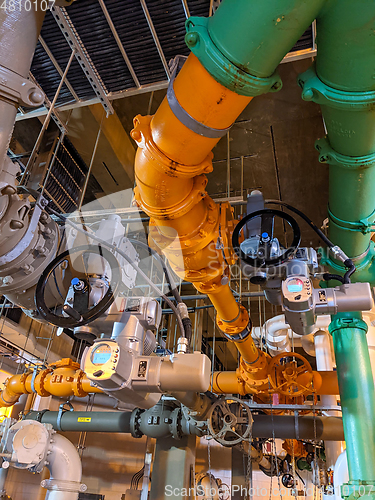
[329,313,375,481]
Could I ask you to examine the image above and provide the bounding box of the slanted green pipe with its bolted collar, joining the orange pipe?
[185,0,327,96]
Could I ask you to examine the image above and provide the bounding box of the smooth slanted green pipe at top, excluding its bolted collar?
[208,0,326,78]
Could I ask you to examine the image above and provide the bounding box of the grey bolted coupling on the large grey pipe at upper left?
[0,66,44,107]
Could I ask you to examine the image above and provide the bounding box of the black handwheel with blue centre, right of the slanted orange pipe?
[232,208,301,268]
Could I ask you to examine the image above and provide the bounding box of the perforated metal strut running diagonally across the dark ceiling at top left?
[51,7,113,115]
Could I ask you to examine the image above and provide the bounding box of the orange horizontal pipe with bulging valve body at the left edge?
[0,358,102,408]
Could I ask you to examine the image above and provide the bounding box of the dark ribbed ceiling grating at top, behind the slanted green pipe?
[24,0,315,116]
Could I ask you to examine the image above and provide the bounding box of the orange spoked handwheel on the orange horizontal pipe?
[268,352,314,397]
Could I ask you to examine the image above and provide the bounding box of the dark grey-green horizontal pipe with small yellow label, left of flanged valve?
[25,411,132,433]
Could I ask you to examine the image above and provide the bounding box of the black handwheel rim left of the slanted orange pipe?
[35,245,122,328]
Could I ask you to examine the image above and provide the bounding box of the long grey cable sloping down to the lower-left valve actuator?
[46,207,186,337]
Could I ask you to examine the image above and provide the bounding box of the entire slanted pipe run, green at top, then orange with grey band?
[131,0,324,385]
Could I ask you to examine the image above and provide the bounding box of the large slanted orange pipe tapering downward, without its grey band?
[131,54,267,383]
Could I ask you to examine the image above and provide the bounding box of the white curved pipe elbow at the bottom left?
[42,434,85,500]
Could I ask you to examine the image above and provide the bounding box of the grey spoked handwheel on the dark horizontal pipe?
[207,397,253,446]
